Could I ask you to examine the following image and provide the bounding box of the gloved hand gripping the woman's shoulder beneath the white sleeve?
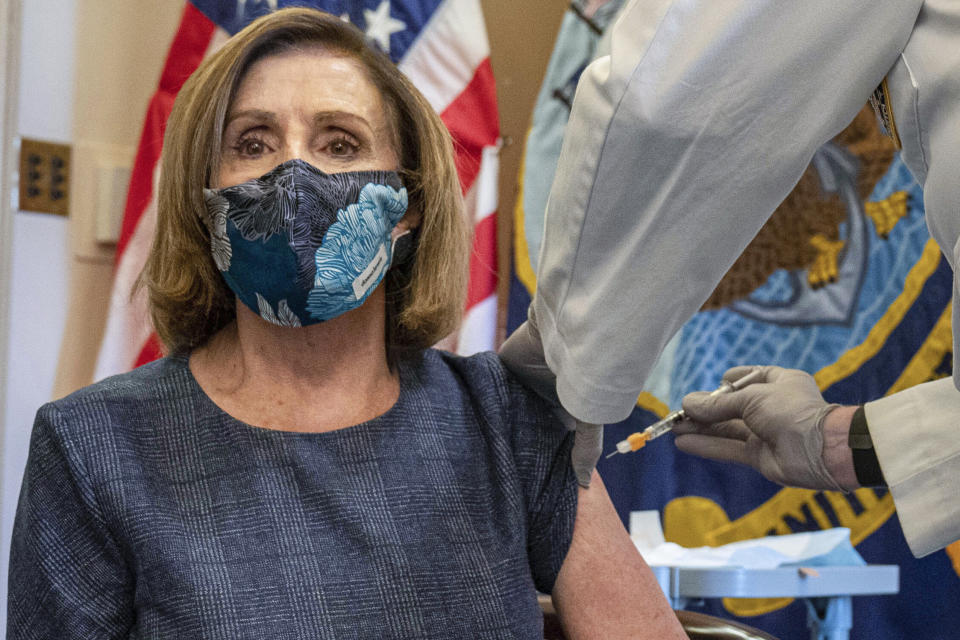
[499,318,603,488]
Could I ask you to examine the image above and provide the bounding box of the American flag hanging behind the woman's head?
[95,0,499,379]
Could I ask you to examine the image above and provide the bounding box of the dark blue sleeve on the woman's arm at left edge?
[7,405,134,640]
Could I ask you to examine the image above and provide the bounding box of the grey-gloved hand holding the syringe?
[673,367,843,491]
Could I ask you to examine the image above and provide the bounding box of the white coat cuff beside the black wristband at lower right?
[864,378,960,558]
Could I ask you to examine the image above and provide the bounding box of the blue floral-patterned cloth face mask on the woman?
[203,159,407,327]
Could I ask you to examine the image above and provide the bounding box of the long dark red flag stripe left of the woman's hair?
[115,2,216,262]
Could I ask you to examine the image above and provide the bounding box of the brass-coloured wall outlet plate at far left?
[17,138,70,216]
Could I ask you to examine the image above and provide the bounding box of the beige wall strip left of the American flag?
[54,0,183,397]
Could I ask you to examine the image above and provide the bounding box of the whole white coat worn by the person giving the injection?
[531,0,960,556]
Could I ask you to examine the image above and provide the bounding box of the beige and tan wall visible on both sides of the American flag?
[54,0,568,397]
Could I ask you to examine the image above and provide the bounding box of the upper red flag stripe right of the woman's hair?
[440,58,500,193]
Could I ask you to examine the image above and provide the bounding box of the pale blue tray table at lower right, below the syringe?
[651,564,900,640]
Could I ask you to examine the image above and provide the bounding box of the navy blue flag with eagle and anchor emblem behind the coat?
[508,0,960,640]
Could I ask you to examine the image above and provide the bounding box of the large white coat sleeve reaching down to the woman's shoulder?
[531,0,921,423]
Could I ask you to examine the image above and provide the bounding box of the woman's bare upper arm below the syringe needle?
[552,472,687,640]
